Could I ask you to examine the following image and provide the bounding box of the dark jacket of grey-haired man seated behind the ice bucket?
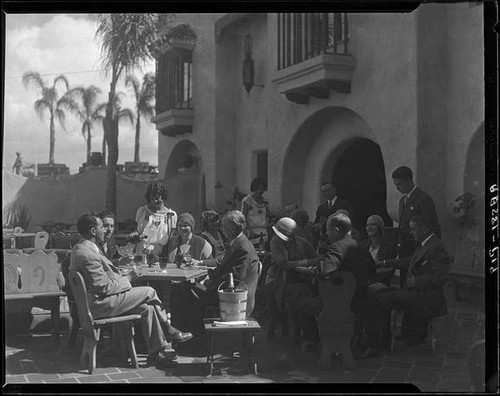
[208,234,259,317]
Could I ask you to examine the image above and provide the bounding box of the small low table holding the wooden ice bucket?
[203,318,261,377]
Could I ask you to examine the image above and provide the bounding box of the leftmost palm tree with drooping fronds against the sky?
[23,71,69,165]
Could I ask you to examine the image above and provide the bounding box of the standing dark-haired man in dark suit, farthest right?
[392,166,441,258]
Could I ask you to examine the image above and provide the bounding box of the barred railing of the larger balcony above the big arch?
[278,13,349,70]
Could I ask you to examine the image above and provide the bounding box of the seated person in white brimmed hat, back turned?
[271,217,320,352]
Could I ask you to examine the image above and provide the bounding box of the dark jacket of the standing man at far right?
[399,186,441,242]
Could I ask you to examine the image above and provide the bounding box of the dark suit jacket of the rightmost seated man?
[386,235,450,316]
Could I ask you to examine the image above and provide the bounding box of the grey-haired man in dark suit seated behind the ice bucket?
[192,210,259,317]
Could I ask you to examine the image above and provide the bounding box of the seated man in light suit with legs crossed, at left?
[69,214,192,368]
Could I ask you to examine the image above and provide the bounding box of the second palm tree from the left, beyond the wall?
[66,85,104,164]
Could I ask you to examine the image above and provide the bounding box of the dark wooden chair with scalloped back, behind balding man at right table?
[318,271,356,370]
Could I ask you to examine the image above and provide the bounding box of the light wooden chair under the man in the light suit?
[68,271,141,374]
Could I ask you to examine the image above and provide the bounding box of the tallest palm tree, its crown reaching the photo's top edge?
[93,13,171,213]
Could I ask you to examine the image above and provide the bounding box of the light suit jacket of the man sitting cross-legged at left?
[69,239,132,318]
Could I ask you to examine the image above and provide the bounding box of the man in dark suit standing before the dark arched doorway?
[313,182,354,242]
